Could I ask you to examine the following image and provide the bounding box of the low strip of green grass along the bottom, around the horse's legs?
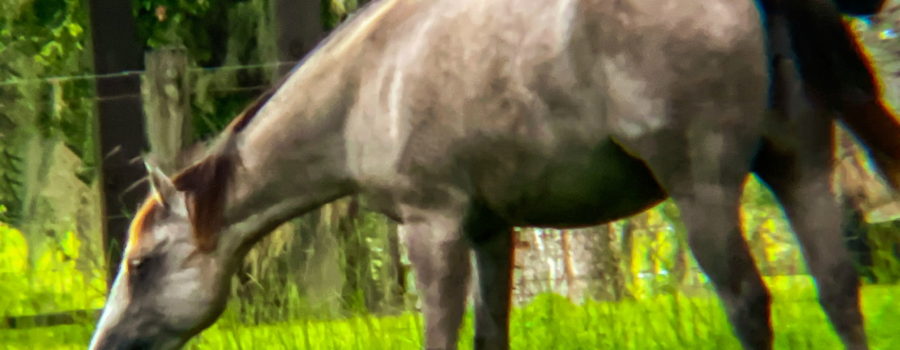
[0,278,900,350]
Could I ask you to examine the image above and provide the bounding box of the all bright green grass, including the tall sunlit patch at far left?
[0,223,900,350]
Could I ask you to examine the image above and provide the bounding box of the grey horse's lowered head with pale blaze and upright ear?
[90,161,239,349]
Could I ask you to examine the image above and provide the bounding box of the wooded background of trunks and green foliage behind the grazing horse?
[0,0,900,342]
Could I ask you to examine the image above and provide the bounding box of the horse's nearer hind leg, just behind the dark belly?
[629,126,773,350]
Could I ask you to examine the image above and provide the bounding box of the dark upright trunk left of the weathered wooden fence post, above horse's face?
[88,0,147,286]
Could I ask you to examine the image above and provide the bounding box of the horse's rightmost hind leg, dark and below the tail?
[754,50,868,350]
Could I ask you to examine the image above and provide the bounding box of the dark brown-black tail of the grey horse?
[781,0,900,192]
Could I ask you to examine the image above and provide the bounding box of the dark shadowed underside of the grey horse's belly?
[487,141,666,227]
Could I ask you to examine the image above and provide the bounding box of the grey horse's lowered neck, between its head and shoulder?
[212,0,421,252]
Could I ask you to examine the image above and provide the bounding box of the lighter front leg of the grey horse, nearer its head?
[400,212,470,350]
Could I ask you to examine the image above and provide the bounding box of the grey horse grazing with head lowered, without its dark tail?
[91,0,896,349]
